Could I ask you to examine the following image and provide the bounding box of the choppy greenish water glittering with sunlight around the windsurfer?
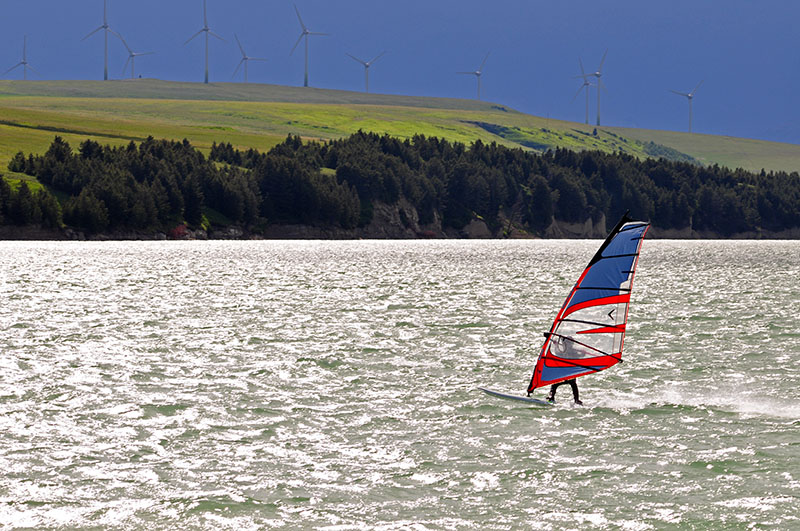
[0,240,800,529]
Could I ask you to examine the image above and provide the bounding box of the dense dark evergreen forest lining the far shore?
[0,132,800,236]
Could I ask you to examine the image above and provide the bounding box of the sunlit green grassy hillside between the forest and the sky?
[0,79,800,178]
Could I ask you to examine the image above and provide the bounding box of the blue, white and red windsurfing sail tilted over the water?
[528,213,650,393]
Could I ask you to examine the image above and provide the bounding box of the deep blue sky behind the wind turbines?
[0,0,800,143]
